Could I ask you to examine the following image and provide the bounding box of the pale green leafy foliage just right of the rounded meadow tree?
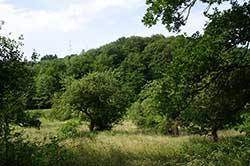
[130,76,186,135]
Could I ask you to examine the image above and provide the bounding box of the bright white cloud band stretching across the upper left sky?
[0,0,142,34]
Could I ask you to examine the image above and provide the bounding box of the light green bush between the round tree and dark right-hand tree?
[129,80,179,136]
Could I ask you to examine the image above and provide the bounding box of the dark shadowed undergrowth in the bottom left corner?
[0,137,70,166]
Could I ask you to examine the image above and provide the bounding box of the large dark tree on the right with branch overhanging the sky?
[143,0,250,141]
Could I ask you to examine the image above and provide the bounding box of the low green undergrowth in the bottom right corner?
[182,137,250,166]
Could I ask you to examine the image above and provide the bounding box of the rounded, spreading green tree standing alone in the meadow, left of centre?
[54,72,130,131]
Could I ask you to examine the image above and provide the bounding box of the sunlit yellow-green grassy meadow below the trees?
[13,110,250,166]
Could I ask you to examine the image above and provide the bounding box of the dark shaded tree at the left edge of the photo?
[0,36,40,160]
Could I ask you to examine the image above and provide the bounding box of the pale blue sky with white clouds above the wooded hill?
[0,0,206,59]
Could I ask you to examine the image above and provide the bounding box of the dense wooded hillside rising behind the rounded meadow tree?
[29,35,175,109]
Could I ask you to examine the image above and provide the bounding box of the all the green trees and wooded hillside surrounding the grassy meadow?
[0,0,250,165]
